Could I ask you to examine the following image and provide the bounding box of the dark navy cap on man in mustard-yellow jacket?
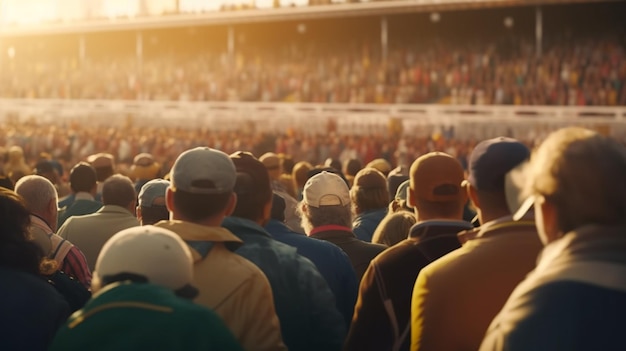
[468,137,530,192]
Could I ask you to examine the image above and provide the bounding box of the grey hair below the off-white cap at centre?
[298,202,352,233]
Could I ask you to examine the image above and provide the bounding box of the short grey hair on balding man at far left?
[15,175,59,214]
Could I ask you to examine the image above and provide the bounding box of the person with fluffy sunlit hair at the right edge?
[480,128,626,350]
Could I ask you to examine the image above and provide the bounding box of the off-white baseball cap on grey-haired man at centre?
[303,171,350,207]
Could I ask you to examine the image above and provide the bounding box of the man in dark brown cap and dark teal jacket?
[222,151,346,350]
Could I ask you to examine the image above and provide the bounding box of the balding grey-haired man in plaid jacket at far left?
[15,175,91,289]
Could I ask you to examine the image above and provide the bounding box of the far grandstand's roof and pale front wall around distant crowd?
[0,0,626,138]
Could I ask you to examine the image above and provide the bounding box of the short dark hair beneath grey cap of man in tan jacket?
[172,189,232,222]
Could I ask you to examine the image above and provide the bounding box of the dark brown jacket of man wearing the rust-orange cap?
[345,220,472,351]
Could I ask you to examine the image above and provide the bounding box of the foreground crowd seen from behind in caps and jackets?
[0,122,626,351]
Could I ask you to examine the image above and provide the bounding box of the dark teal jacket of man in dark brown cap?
[222,217,346,351]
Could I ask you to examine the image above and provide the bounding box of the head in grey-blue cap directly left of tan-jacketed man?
[137,179,170,225]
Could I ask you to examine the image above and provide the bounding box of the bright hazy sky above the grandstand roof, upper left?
[0,0,308,24]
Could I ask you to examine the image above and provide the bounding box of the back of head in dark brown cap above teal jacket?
[230,151,272,222]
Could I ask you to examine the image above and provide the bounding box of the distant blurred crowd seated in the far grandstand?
[0,37,626,106]
